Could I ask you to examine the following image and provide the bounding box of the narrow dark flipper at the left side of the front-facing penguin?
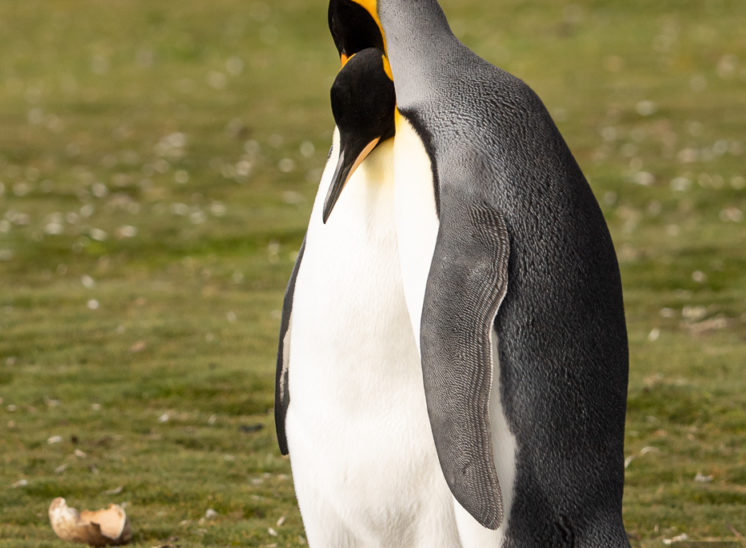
[275,238,306,455]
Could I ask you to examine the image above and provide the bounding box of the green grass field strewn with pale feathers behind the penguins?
[0,0,746,548]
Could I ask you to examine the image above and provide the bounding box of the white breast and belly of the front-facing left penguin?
[286,132,458,546]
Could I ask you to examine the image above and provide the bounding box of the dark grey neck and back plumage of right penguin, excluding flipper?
[379,0,628,546]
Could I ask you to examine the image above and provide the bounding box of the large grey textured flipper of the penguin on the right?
[420,194,509,529]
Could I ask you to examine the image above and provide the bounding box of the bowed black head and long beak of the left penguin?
[323,48,396,223]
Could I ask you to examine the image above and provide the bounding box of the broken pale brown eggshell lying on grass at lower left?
[49,497,132,546]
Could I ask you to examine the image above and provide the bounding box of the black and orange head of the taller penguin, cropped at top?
[329,0,386,65]
